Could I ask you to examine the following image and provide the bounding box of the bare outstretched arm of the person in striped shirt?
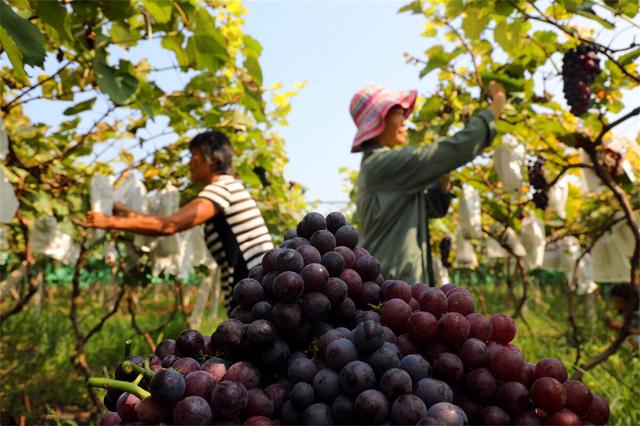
[85,198,218,236]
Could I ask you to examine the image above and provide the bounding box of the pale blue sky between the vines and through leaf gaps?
[11,0,640,213]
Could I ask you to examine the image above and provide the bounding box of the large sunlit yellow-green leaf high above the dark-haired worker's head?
[192,8,229,72]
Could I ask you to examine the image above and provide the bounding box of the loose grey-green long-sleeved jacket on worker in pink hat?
[356,110,496,284]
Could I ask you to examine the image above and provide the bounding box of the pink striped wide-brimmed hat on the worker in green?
[349,83,417,152]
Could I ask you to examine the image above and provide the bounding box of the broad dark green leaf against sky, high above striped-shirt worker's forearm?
[93,52,138,104]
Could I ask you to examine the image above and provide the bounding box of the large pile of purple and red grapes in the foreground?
[94,213,609,425]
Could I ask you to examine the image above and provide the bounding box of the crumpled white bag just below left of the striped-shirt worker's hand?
[29,216,80,265]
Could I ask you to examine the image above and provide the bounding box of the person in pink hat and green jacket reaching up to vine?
[350,81,506,285]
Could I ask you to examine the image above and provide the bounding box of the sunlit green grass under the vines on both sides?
[0,282,640,426]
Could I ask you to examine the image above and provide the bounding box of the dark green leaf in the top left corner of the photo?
[0,2,46,67]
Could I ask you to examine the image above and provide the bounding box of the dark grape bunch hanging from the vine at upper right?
[562,44,602,117]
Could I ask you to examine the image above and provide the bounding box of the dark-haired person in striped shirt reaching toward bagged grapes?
[85,131,273,306]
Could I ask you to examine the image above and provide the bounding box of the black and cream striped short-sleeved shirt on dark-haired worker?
[198,175,273,307]
